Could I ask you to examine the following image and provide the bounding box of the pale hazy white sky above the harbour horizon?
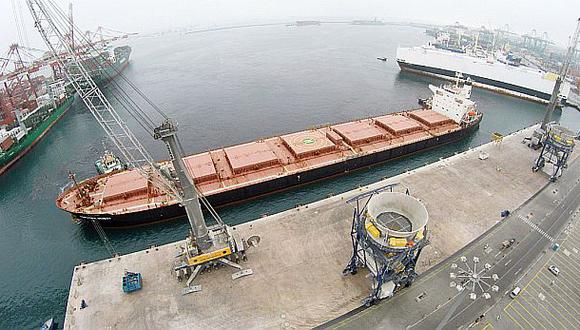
[0,0,580,56]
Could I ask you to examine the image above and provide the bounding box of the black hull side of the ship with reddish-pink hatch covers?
[70,117,481,228]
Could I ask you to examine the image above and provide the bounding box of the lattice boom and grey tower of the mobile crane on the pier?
[27,0,213,251]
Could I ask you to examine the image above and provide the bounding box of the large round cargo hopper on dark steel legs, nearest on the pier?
[342,184,429,306]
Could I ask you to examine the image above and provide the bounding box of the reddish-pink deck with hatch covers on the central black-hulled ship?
[58,109,460,214]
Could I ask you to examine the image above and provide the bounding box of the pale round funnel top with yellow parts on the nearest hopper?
[365,192,429,248]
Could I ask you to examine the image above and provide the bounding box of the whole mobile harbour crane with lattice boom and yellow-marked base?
[26,0,251,290]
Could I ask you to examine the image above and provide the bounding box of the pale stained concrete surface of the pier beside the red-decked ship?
[65,125,578,329]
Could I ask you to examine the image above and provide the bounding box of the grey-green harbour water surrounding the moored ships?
[0,24,580,329]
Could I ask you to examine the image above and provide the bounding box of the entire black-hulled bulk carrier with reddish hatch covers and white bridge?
[56,81,482,227]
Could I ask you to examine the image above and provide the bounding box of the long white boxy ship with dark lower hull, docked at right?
[397,45,570,104]
